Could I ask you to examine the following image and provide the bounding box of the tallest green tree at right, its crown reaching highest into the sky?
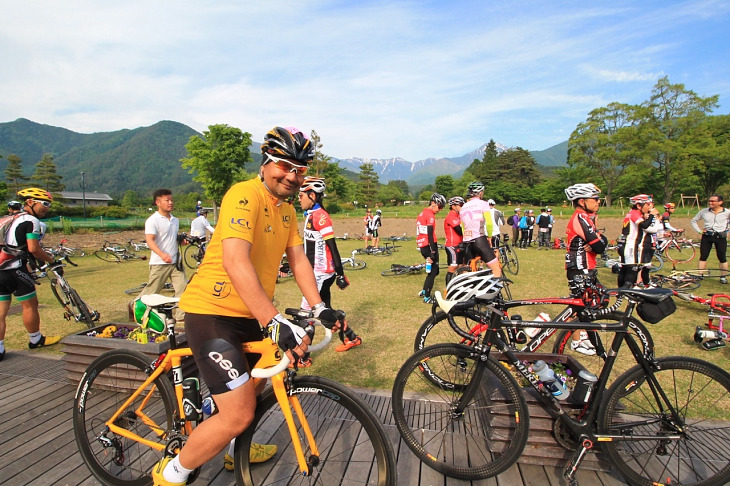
[640,76,719,201]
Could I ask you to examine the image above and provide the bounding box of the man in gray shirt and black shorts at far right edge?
[692,194,730,284]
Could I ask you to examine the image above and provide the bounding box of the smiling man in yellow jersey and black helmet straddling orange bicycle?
[152,127,336,486]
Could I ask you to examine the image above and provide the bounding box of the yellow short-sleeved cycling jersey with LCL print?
[180,177,302,318]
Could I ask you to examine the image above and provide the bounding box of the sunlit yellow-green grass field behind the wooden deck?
[5,235,730,389]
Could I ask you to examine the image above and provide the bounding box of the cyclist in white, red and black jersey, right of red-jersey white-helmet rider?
[618,194,659,287]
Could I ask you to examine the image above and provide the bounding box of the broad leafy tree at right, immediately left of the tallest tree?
[568,103,643,207]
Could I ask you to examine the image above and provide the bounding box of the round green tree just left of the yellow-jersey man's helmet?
[180,124,253,206]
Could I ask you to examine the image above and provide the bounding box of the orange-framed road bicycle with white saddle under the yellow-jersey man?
[73,294,396,486]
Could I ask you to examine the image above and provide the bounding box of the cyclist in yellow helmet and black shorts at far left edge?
[0,187,61,361]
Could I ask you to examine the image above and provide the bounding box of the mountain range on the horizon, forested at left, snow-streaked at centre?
[0,118,568,198]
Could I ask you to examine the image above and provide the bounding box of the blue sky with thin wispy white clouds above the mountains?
[0,0,730,161]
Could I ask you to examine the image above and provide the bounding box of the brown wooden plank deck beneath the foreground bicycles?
[0,351,625,486]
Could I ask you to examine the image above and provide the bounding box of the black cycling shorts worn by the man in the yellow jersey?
[185,312,264,395]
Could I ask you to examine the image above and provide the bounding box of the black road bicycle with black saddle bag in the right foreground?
[392,289,730,486]
